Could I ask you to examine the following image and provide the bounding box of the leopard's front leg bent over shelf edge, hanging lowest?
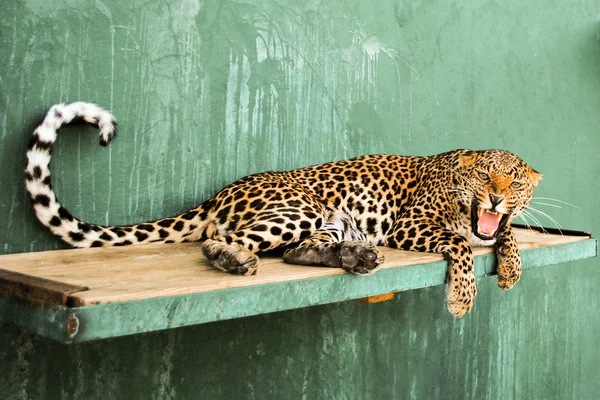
[386,218,477,317]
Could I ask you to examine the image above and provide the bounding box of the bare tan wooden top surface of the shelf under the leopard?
[0,229,586,306]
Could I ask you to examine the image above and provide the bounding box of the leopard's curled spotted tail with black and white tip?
[25,102,206,247]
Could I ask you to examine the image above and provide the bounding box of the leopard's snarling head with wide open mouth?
[453,150,542,240]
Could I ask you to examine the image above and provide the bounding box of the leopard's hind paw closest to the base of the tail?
[202,239,258,275]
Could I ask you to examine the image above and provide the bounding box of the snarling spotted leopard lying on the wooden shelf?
[25,102,542,317]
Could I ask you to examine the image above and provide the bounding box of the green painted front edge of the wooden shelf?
[0,239,597,343]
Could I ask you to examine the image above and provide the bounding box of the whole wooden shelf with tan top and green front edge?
[0,229,597,343]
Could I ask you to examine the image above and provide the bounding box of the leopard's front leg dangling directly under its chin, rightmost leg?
[496,225,522,290]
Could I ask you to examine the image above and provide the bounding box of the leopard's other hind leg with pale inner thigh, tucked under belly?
[283,211,384,275]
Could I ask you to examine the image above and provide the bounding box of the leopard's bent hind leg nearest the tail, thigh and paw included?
[202,180,327,275]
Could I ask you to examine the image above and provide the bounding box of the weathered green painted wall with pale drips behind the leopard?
[0,0,600,400]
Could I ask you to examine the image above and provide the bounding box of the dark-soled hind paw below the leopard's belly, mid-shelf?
[338,241,385,275]
